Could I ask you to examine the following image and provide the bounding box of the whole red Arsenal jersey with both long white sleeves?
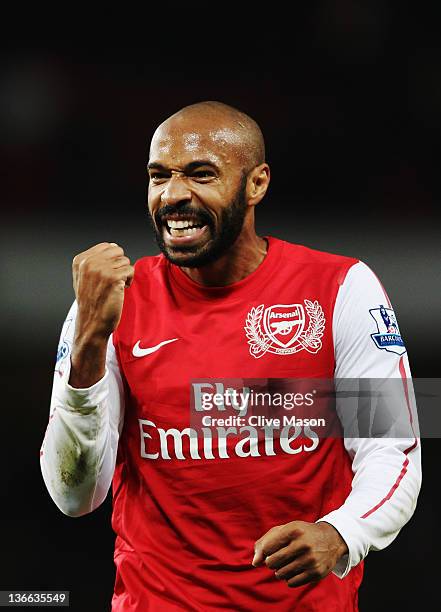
[41,237,421,612]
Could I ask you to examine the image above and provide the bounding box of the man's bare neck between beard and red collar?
[182,227,268,287]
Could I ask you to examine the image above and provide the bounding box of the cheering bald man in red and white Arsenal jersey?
[41,102,420,612]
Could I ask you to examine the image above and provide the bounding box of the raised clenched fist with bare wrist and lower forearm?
[69,242,134,387]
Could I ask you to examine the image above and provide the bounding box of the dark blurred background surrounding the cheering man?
[0,1,441,612]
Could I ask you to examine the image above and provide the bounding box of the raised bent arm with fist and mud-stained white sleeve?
[40,243,133,516]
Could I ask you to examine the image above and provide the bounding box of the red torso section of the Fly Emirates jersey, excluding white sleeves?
[113,238,362,612]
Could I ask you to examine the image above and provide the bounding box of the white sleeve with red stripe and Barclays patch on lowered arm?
[320,262,421,578]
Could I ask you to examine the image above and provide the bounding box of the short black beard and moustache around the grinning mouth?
[148,174,247,268]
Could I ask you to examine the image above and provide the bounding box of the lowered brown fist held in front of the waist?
[253,521,348,587]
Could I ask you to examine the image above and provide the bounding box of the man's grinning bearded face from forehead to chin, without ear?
[148,119,247,267]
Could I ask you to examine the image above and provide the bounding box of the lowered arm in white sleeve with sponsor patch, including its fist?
[253,263,421,587]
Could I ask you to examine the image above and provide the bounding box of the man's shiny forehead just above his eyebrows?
[150,119,243,166]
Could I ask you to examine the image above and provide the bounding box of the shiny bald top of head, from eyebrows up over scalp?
[152,102,265,171]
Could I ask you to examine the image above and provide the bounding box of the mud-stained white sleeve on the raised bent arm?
[40,302,124,516]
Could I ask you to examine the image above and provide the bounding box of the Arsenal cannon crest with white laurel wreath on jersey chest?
[244,300,326,359]
